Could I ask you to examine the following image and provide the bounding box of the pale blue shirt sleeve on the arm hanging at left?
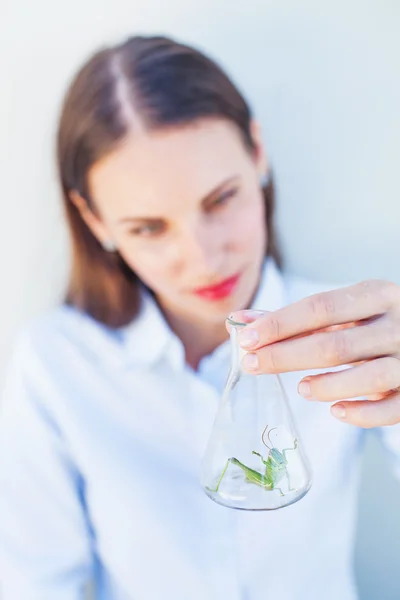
[0,340,92,600]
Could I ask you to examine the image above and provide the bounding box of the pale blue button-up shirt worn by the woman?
[0,261,400,600]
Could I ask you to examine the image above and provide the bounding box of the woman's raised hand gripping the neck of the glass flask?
[232,280,400,427]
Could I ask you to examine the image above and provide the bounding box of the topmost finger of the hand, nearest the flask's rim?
[233,280,400,349]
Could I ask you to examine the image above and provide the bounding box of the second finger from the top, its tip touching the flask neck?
[243,319,400,373]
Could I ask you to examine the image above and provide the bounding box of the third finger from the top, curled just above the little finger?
[298,357,400,402]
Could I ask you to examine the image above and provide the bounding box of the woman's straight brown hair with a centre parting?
[57,37,281,327]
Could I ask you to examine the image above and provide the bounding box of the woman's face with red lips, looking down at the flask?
[89,119,267,323]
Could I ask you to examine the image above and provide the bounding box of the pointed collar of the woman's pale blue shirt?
[122,258,285,368]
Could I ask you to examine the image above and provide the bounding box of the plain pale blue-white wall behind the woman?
[0,0,400,600]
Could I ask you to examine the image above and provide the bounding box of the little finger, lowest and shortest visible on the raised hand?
[331,392,400,428]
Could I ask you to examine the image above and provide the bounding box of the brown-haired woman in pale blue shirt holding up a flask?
[0,37,400,600]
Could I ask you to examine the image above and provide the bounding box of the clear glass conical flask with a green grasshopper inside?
[200,311,311,510]
